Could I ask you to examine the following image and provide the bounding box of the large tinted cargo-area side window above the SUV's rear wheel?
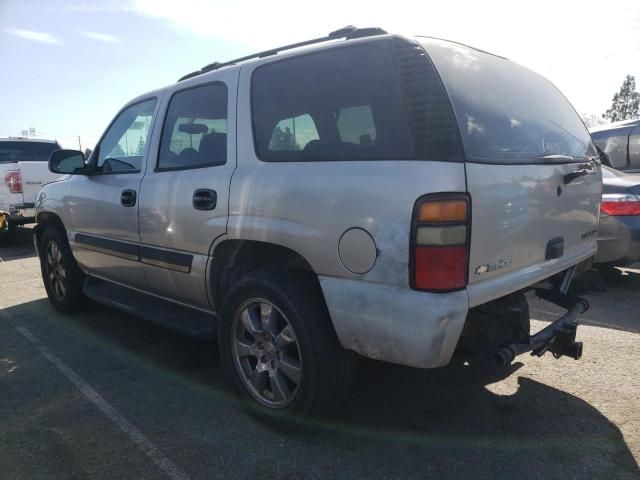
[252,45,416,162]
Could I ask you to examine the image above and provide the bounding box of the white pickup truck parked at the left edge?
[0,137,60,247]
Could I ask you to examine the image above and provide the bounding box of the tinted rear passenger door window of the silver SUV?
[158,83,227,170]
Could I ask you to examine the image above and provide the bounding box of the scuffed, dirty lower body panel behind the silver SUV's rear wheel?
[320,276,469,368]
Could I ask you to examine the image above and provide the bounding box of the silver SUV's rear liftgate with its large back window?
[421,40,602,306]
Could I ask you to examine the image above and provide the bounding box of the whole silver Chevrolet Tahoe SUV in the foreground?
[35,27,602,418]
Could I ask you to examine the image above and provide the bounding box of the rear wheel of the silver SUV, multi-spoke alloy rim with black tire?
[218,270,355,429]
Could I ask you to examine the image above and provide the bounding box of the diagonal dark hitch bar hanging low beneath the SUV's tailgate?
[494,298,589,366]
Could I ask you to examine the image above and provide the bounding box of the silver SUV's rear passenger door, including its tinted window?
[140,70,238,310]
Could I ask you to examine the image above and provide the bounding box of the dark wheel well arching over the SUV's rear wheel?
[209,240,320,306]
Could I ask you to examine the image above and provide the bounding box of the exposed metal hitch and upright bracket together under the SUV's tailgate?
[494,266,589,365]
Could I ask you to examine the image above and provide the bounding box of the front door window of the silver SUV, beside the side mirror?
[96,98,156,173]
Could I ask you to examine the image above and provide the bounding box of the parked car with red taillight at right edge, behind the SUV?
[594,166,640,267]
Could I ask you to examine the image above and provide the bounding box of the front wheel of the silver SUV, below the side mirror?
[39,226,86,313]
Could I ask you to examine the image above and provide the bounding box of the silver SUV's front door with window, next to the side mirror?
[68,98,157,287]
